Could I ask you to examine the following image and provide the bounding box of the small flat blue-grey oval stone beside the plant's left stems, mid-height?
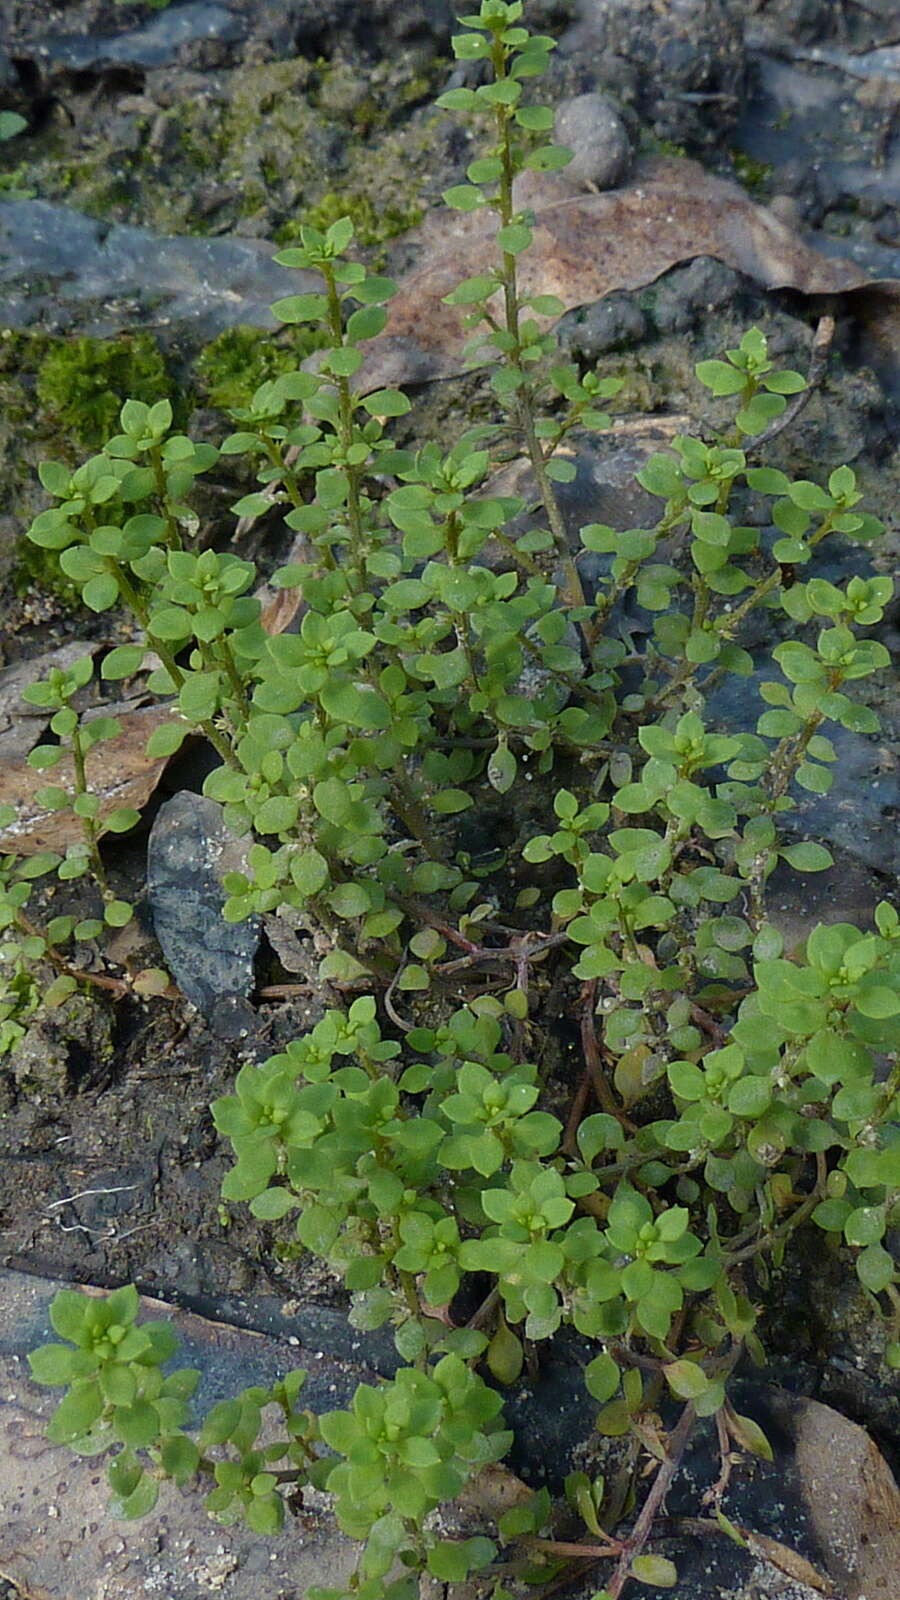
[147,789,259,1017]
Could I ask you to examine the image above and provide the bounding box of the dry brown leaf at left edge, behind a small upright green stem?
[0,706,182,856]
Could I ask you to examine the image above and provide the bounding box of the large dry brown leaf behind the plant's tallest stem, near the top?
[356,158,900,390]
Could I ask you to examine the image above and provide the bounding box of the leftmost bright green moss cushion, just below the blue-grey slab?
[37,333,173,450]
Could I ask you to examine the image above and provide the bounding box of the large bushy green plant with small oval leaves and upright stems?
[24,0,900,1600]
